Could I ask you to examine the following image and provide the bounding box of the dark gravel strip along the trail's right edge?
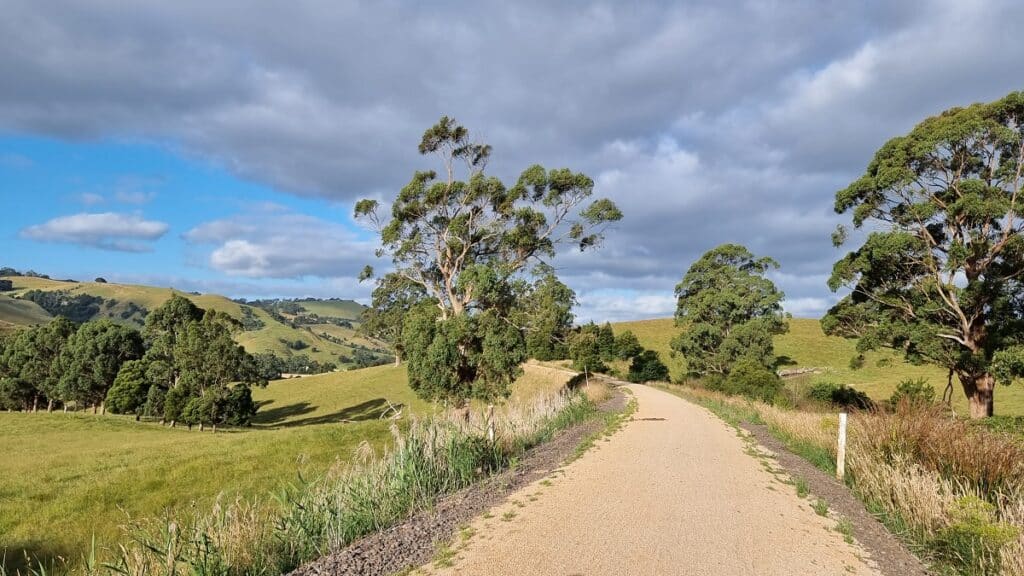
[741,423,929,576]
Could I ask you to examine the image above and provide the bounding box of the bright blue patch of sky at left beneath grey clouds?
[0,135,375,297]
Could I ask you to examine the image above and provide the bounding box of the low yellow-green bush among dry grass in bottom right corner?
[932,496,1019,576]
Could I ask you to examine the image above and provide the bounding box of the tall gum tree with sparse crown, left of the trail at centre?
[355,117,622,403]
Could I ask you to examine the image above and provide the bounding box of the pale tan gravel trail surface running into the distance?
[417,385,879,576]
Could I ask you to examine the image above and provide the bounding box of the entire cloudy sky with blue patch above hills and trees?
[0,0,1024,322]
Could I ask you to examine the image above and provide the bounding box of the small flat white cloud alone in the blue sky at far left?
[22,212,170,252]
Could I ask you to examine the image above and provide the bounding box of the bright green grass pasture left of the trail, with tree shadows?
[0,366,567,566]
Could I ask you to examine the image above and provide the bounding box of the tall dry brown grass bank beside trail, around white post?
[666,385,1024,576]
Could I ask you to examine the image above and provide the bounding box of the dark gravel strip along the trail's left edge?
[291,390,626,576]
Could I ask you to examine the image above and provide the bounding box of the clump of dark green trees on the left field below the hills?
[0,294,266,429]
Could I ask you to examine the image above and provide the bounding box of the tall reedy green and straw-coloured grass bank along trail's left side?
[4,381,596,576]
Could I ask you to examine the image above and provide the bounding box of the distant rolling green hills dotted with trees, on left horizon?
[0,276,388,367]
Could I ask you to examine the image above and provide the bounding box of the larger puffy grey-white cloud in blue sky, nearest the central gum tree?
[184,206,373,279]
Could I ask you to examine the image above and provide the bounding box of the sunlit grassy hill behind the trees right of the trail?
[614,318,1024,415]
